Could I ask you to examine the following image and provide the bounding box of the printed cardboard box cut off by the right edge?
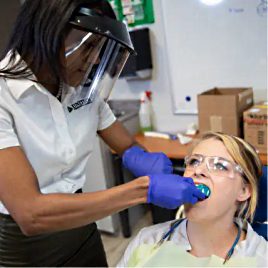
[243,102,268,154]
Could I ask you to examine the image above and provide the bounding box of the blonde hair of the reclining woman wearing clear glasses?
[192,132,262,222]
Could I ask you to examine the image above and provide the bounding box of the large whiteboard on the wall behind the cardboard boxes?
[161,0,267,114]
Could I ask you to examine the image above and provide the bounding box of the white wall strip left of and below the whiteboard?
[111,0,198,132]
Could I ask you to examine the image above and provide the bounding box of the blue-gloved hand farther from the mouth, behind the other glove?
[122,146,173,177]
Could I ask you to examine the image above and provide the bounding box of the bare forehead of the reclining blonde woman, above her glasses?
[192,138,233,161]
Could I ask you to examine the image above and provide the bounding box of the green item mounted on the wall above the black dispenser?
[109,0,155,27]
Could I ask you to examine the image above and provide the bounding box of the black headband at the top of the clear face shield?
[70,7,136,54]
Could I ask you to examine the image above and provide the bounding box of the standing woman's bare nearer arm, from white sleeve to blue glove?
[0,147,149,236]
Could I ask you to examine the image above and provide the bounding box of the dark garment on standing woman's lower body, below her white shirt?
[0,211,108,267]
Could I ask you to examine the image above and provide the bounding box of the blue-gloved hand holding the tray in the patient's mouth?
[147,174,206,209]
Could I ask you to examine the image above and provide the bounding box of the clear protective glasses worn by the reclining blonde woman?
[185,154,244,178]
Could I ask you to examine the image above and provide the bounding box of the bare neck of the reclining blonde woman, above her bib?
[187,217,243,258]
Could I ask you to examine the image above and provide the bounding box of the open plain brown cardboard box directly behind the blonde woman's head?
[198,88,253,137]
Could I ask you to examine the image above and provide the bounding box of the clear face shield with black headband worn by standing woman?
[64,8,134,107]
